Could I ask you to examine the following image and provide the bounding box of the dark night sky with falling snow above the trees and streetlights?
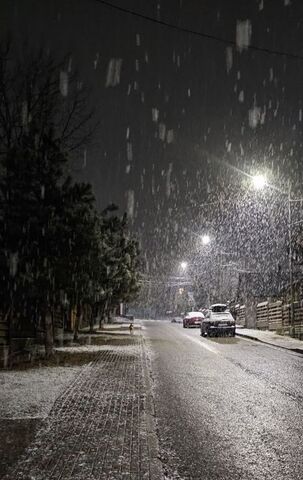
[1,0,303,274]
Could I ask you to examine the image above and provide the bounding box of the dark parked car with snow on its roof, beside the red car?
[201,303,236,337]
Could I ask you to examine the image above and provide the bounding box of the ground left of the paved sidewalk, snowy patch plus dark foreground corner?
[0,366,81,479]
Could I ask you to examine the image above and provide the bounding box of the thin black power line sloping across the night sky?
[95,0,303,60]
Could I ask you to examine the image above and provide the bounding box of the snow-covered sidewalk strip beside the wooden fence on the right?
[236,328,303,354]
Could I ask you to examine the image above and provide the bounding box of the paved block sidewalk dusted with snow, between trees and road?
[4,334,163,480]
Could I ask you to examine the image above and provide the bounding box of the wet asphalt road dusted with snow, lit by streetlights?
[144,321,303,480]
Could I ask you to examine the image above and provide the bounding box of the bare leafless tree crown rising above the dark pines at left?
[0,43,94,154]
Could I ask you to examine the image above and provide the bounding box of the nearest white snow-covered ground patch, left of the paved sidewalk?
[0,366,81,419]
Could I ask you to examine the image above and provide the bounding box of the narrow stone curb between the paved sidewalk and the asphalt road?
[142,336,164,480]
